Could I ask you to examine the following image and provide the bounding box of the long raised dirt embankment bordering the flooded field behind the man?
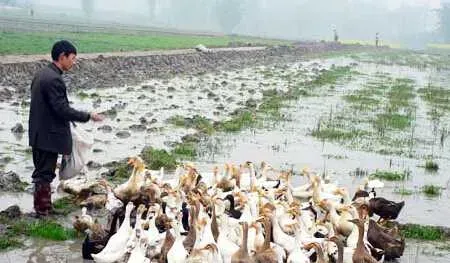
[0,43,380,101]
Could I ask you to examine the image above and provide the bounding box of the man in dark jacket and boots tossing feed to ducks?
[28,40,104,217]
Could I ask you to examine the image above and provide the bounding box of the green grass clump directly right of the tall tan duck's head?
[141,147,177,170]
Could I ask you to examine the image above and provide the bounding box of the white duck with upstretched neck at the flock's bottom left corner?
[91,202,134,263]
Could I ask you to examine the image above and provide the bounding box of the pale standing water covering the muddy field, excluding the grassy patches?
[0,51,450,263]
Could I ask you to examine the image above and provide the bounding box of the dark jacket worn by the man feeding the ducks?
[28,63,90,154]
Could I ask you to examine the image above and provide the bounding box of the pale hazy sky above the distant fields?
[18,0,444,46]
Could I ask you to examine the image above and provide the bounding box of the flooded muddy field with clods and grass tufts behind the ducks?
[0,46,450,262]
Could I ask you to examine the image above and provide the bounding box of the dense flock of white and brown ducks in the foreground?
[73,157,405,263]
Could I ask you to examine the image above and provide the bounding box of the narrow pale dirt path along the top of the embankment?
[0,47,266,64]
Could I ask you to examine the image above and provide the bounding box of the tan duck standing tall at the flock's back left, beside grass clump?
[114,157,145,202]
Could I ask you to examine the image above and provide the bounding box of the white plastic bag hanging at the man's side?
[59,123,94,180]
